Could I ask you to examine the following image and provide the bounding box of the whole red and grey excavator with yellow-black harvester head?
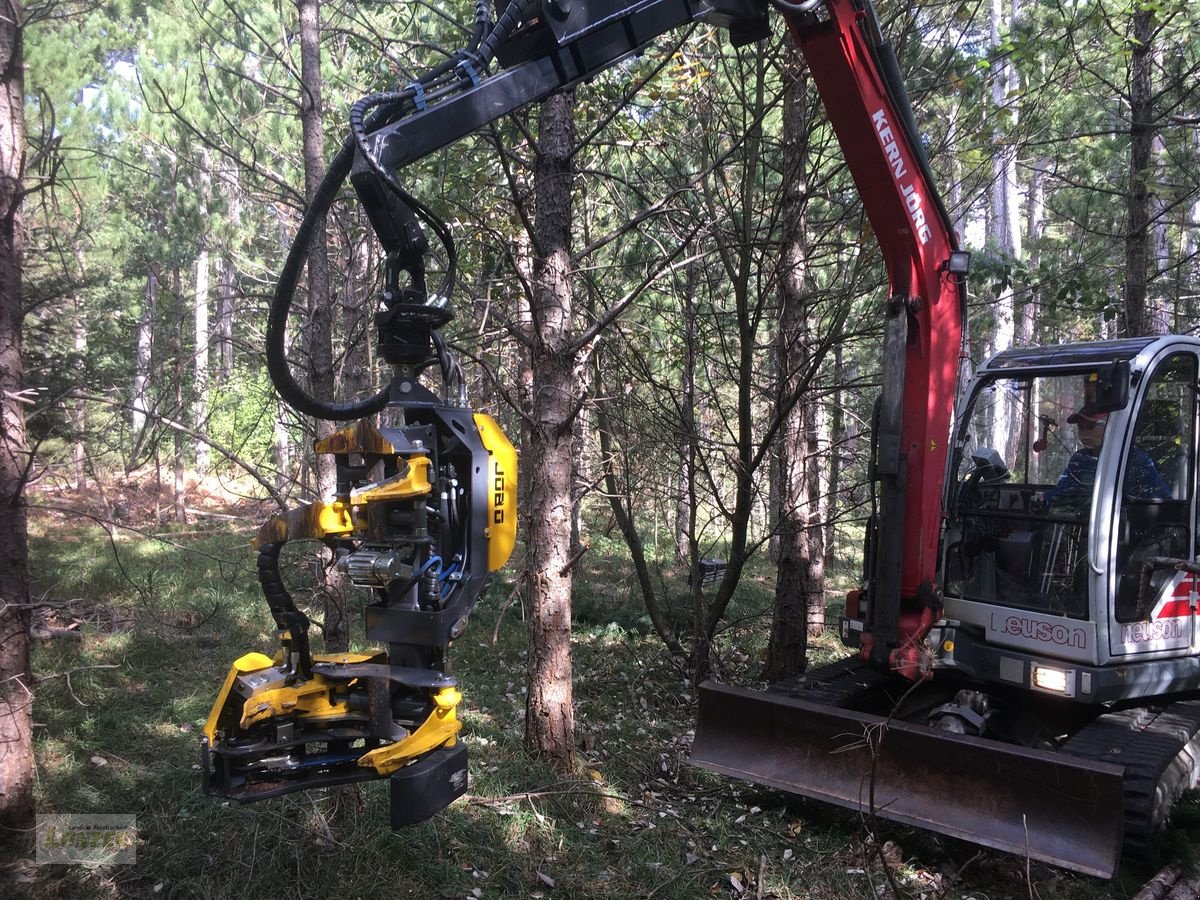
[200,0,1200,877]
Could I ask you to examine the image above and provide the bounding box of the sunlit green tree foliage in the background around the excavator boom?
[28,0,1200,499]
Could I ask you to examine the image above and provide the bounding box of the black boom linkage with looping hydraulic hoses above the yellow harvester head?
[266,0,768,421]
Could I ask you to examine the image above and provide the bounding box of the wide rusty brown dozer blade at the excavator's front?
[691,682,1123,878]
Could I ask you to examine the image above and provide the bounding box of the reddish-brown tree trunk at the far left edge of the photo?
[0,0,34,844]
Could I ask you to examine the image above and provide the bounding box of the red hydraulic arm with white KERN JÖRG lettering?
[775,0,967,678]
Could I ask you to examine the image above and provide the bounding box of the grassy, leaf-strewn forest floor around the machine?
[11,480,1200,900]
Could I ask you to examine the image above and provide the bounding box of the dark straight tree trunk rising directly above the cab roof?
[1122,4,1154,337]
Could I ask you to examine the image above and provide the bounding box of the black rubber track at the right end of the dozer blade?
[1062,701,1200,859]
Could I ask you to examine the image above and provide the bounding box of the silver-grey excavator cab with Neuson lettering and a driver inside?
[934,338,1200,681]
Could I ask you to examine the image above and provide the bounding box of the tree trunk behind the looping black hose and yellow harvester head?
[296,0,349,653]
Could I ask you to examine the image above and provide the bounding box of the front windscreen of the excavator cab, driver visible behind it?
[943,357,1128,618]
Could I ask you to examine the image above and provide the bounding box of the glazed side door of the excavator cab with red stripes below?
[1108,350,1196,656]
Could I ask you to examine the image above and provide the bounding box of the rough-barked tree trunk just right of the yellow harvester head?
[526,94,578,770]
